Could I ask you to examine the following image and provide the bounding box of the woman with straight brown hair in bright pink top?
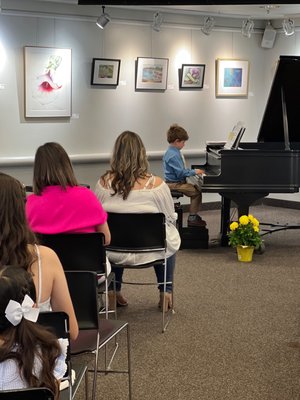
[26,143,110,244]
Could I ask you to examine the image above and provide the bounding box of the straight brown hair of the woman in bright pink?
[33,142,78,195]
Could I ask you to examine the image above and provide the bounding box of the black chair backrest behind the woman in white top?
[107,212,166,252]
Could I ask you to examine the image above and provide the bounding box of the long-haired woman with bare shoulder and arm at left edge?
[0,173,78,339]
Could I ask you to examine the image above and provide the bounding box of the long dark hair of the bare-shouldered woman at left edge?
[0,172,36,269]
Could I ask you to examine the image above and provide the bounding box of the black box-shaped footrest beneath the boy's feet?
[179,226,209,249]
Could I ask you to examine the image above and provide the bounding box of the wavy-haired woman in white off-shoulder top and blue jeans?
[95,131,180,309]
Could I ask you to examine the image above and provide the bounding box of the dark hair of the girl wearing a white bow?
[0,266,61,393]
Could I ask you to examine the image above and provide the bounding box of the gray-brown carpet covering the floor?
[71,206,300,400]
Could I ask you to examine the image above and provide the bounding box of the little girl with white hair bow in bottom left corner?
[0,266,68,399]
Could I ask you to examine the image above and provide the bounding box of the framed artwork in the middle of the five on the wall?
[135,57,169,90]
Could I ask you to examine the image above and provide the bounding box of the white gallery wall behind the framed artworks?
[0,0,300,201]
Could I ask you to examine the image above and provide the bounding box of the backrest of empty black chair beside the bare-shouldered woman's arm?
[65,271,99,330]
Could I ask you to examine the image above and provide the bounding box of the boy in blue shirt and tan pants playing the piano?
[163,124,206,227]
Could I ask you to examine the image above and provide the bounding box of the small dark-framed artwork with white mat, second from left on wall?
[91,58,121,86]
